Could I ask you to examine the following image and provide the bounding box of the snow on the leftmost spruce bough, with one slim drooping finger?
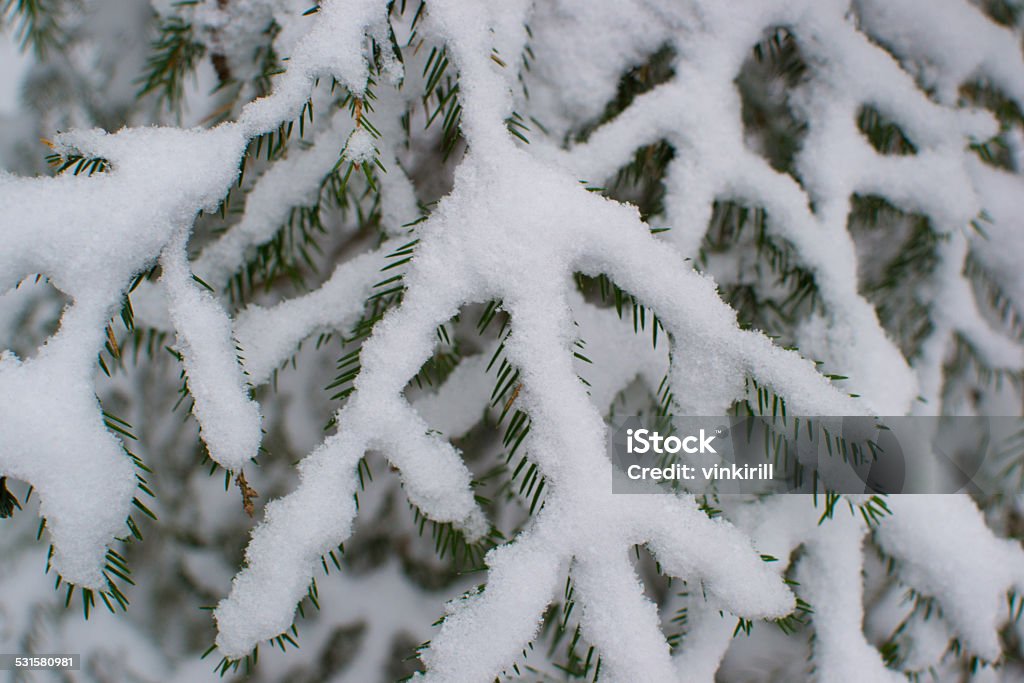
[0,2,415,588]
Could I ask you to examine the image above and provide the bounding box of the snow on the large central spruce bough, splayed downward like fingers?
[215,6,856,663]
